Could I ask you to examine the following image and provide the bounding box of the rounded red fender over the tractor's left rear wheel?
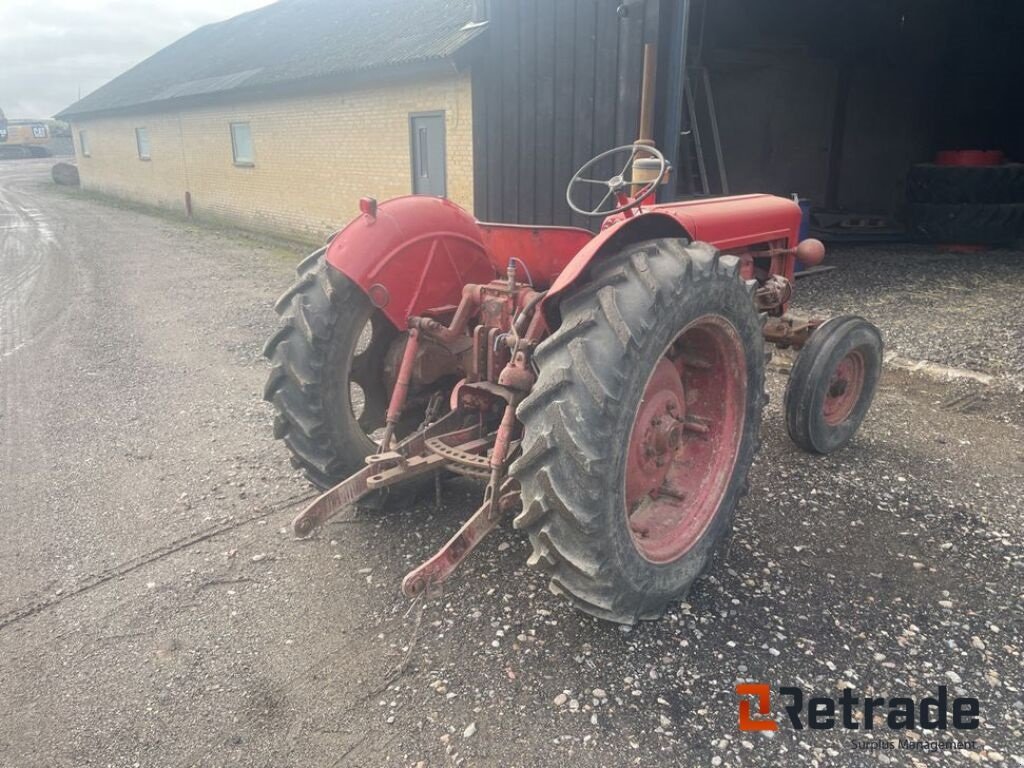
[326,195,495,330]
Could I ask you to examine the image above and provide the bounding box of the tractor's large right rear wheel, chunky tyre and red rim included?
[511,240,765,624]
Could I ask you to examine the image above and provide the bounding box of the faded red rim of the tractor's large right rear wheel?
[624,314,748,563]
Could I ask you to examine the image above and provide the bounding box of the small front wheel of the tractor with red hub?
[785,315,883,454]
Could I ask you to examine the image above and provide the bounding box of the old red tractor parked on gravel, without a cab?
[265,143,882,623]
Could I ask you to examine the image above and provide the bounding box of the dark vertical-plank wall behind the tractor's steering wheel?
[472,0,657,226]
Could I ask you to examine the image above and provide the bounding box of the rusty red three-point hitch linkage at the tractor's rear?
[293,261,547,597]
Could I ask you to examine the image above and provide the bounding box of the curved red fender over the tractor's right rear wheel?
[541,211,694,330]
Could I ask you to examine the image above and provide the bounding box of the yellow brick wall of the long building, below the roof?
[74,73,473,240]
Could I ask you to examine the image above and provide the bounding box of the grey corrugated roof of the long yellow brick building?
[58,0,484,117]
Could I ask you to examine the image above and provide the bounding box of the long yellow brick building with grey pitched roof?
[59,0,485,240]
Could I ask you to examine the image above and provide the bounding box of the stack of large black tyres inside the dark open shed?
[906,155,1024,240]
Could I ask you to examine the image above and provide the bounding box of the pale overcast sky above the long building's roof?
[0,0,270,118]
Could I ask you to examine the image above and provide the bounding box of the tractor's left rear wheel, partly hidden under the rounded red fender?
[263,248,401,488]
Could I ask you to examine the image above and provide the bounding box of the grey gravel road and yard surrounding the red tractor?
[0,161,1024,768]
